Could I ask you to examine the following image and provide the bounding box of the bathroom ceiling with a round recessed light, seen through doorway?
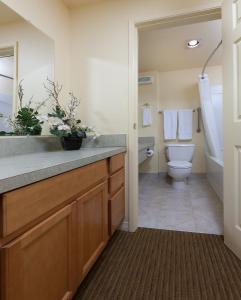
[139,20,222,72]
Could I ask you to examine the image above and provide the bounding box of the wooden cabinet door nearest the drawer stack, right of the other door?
[77,183,108,282]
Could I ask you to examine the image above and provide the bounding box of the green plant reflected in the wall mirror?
[5,81,47,135]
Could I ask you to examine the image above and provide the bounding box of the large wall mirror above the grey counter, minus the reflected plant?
[0,1,54,135]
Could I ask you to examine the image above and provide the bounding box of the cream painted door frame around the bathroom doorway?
[128,5,222,232]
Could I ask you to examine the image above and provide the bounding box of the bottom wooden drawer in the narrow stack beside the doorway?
[109,187,125,235]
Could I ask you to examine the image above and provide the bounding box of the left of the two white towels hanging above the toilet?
[163,109,177,140]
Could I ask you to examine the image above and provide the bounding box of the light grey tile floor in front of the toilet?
[139,174,223,234]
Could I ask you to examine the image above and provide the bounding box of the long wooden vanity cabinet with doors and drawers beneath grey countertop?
[0,147,125,300]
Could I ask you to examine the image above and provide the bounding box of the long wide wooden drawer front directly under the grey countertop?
[0,160,108,237]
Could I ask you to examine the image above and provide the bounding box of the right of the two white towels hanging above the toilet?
[178,109,193,140]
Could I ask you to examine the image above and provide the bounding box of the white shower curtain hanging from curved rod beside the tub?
[199,74,222,159]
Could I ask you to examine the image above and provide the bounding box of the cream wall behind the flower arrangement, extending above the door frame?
[68,0,221,133]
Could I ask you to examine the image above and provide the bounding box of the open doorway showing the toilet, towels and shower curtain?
[138,18,223,235]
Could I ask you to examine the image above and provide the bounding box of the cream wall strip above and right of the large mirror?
[2,0,70,90]
